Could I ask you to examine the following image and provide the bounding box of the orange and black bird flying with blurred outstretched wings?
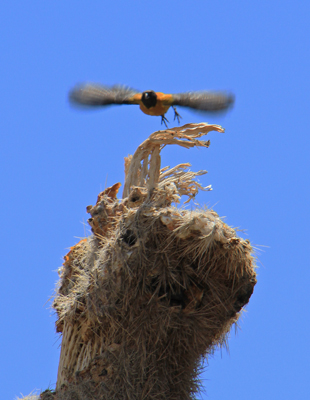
[69,84,234,127]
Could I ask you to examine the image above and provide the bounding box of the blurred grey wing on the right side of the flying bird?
[172,91,234,112]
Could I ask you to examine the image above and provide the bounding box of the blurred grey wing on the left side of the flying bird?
[69,83,139,106]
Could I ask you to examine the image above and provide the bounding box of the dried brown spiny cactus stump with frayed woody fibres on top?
[52,124,256,400]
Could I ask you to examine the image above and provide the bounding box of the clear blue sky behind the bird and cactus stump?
[0,0,310,400]
